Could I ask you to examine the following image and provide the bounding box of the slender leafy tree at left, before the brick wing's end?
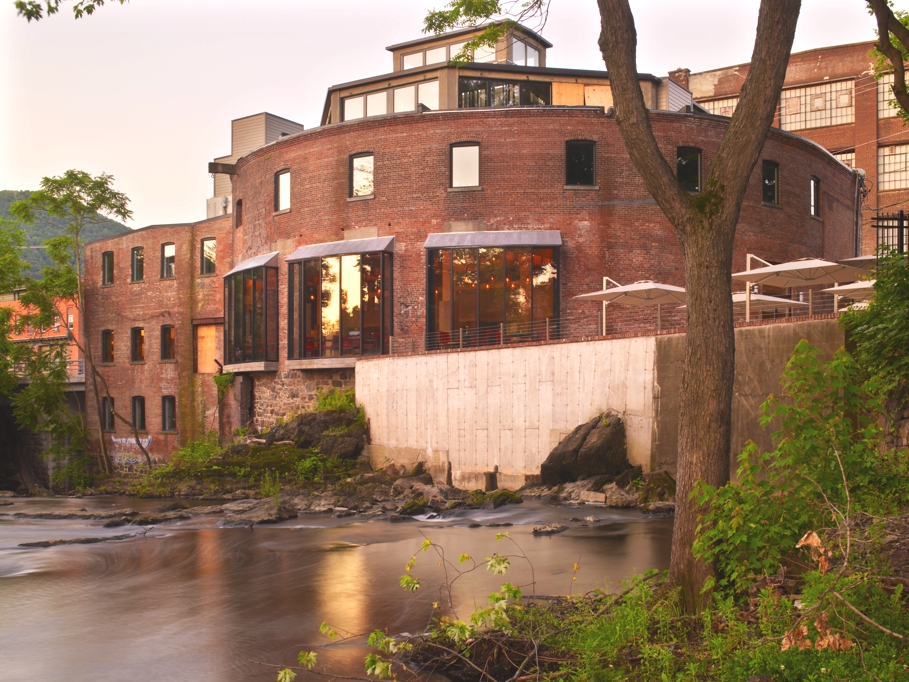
[10,170,151,473]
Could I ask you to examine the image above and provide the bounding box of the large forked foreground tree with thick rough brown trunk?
[425,0,801,609]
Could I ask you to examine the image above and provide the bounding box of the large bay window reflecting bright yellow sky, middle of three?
[287,253,392,359]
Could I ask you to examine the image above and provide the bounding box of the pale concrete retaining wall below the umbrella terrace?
[356,319,843,488]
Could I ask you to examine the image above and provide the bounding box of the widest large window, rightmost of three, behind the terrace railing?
[426,246,559,348]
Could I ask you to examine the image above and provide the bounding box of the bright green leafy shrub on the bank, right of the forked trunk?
[694,341,909,592]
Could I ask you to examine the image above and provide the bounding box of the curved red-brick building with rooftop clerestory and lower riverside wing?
[80,29,858,460]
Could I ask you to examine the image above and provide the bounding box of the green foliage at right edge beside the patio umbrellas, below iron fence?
[840,251,909,396]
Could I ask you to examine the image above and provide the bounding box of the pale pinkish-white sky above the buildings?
[0,0,880,227]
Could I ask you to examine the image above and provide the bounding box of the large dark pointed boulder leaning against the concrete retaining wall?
[540,410,631,489]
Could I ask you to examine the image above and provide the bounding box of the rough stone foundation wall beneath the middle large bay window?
[251,368,354,431]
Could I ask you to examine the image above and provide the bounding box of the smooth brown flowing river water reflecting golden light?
[0,497,672,682]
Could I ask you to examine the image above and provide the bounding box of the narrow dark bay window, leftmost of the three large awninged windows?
[224,266,278,364]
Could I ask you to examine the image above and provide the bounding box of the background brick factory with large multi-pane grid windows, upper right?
[688,42,909,254]
